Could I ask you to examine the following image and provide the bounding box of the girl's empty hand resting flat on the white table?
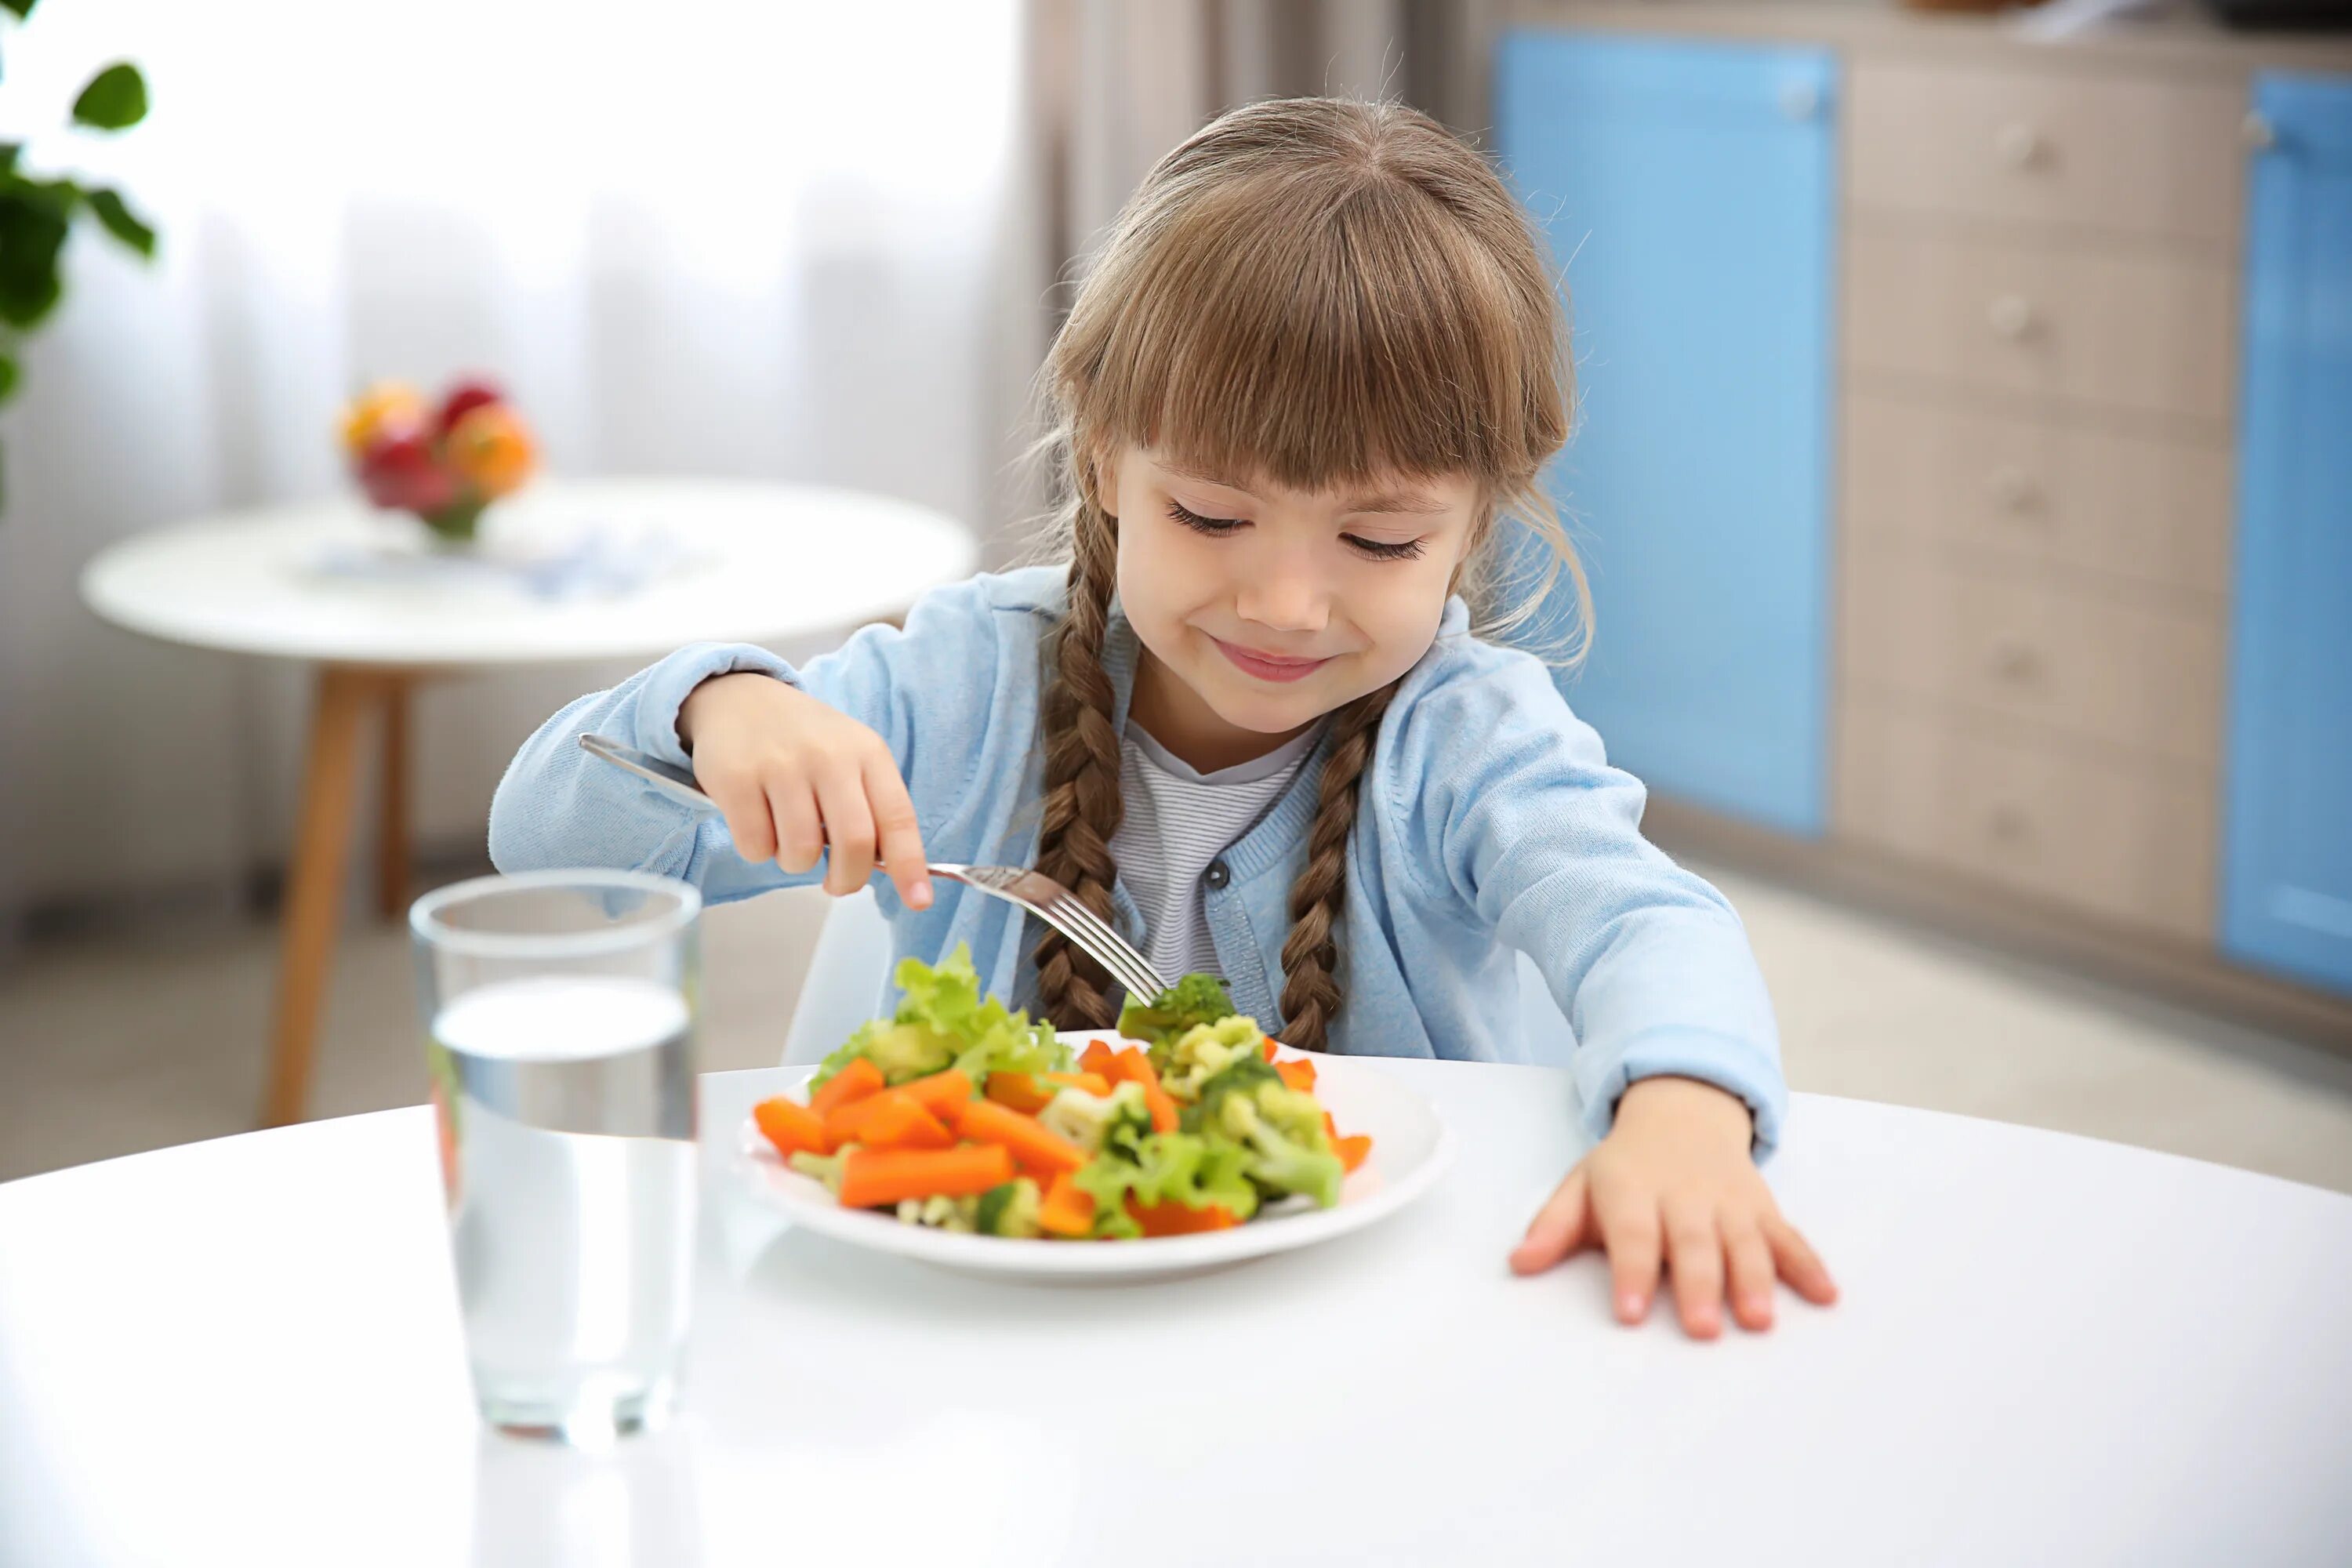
[1510,1079,1837,1340]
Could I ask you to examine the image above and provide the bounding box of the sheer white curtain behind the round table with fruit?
[0,0,1030,928]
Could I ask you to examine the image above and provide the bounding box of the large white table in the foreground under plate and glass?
[0,1062,2352,1568]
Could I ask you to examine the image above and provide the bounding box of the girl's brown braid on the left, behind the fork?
[1037,499,1124,1029]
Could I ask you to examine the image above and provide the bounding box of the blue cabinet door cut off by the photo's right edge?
[2220,75,2352,992]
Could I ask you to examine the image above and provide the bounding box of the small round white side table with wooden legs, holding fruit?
[82,480,978,1123]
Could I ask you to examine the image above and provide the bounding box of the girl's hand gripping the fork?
[677,670,931,909]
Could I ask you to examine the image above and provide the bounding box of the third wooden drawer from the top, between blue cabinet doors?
[1842,393,2230,602]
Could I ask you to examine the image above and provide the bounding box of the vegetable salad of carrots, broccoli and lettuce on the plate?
[753,947,1371,1241]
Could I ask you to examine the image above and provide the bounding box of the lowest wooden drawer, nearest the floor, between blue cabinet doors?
[1837,691,2216,940]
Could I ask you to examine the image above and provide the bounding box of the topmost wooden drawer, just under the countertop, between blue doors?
[1846,56,2246,252]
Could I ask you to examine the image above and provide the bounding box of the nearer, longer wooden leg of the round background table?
[261,666,381,1126]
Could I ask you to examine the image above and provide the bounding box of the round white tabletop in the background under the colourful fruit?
[82,480,978,668]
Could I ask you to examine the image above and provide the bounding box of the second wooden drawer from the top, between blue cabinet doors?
[1846,219,2237,428]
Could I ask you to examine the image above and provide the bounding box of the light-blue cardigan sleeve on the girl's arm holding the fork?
[489,579,1002,902]
